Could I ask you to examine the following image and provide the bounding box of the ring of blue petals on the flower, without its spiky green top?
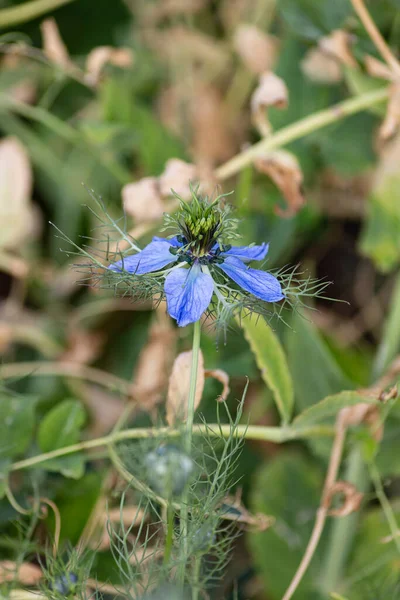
[109,235,284,327]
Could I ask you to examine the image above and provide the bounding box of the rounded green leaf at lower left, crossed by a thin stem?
[38,400,86,479]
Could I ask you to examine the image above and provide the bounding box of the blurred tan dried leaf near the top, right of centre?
[233,23,279,75]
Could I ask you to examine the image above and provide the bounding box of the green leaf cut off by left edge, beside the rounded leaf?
[0,393,37,457]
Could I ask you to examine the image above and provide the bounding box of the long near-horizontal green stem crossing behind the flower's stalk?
[10,423,333,471]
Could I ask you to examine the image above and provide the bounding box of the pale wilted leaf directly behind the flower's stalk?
[166,350,204,426]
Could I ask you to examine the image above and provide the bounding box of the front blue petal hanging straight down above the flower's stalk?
[164,265,214,327]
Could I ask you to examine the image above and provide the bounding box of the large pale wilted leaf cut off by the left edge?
[0,137,35,249]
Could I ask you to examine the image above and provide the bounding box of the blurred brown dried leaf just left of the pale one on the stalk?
[132,310,176,411]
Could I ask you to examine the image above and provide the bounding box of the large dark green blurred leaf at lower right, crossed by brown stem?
[247,453,323,600]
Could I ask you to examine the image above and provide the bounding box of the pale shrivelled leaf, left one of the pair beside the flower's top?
[122,177,165,223]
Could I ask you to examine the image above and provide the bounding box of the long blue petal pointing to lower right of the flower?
[216,256,285,302]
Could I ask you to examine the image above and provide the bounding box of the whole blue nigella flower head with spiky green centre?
[109,189,285,327]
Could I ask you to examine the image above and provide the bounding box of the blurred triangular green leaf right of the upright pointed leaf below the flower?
[286,315,353,410]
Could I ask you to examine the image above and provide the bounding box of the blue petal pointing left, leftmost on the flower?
[108,241,176,275]
